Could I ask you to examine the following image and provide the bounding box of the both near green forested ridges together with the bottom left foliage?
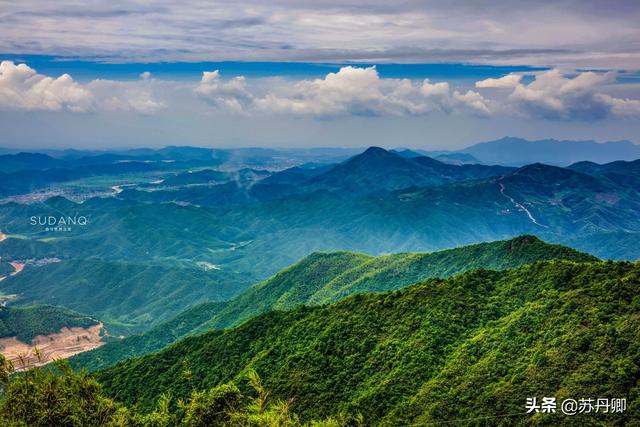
[0,236,640,427]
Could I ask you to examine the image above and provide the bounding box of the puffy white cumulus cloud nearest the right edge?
[476,69,640,120]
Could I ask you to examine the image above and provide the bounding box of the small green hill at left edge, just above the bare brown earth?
[0,305,98,344]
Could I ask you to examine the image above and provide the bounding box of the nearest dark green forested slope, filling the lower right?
[97,261,640,425]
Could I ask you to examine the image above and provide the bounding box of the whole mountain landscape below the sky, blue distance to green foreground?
[0,141,640,425]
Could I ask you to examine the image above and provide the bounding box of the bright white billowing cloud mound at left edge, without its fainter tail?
[0,61,95,112]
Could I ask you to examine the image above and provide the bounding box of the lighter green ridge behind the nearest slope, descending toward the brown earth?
[72,236,597,370]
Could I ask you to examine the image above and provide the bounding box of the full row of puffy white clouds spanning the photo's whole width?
[0,61,640,121]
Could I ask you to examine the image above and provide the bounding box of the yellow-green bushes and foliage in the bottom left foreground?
[0,355,352,427]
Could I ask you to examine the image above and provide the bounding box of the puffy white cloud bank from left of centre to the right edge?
[196,66,640,120]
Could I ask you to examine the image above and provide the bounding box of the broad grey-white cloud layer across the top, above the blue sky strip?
[0,0,640,70]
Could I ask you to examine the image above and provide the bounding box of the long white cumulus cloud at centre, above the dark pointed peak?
[201,66,489,117]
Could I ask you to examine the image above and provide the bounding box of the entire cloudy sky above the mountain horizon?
[0,0,640,150]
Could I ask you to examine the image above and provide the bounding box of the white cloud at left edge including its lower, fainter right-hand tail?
[0,61,165,114]
